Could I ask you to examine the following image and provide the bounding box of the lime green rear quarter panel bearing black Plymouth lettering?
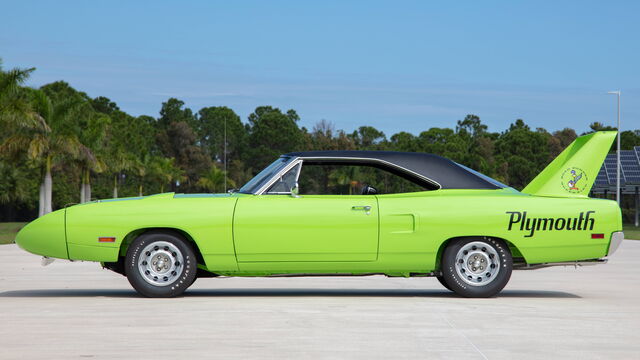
[378,189,622,270]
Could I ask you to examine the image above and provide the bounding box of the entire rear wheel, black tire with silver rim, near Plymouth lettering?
[442,237,513,298]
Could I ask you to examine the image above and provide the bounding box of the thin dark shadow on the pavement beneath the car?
[0,288,581,299]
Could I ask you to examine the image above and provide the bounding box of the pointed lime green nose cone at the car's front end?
[16,209,69,259]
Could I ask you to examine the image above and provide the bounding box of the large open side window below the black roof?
[298,162,427,195]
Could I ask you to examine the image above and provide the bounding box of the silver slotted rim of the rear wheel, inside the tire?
[455,241,500,286]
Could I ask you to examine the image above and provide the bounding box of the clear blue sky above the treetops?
[0,0,640,135]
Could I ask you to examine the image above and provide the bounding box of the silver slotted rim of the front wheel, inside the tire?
[138,241,184,286]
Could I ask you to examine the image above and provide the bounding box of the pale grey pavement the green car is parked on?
[0,240,640,359]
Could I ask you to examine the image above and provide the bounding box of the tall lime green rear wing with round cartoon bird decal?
[521,131,617,198]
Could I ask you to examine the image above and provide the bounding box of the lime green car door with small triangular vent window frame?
[233,162,378,262]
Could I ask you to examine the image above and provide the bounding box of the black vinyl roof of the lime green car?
[285,150,503,189]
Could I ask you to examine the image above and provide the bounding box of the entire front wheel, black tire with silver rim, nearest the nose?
[125,231,197,297]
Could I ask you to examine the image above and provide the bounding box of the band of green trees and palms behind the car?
[0,63,640,221]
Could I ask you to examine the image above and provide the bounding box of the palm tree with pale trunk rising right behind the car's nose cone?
[0,89,82,216]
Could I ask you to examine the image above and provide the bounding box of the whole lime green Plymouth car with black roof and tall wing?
[16,132,624,297]
